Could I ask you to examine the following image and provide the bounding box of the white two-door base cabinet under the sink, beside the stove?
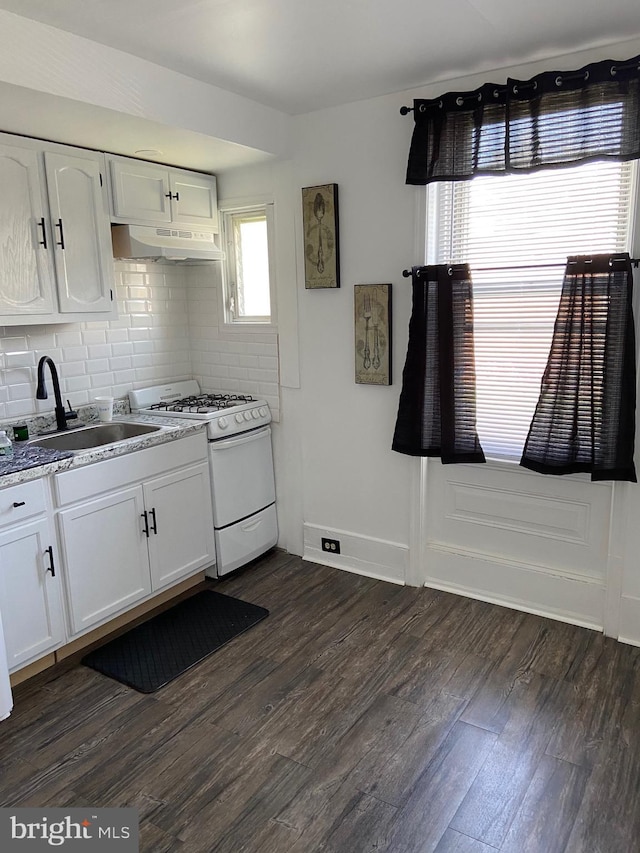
[55,435,215,636]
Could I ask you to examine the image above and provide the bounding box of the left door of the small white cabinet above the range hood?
[110,159,171,223]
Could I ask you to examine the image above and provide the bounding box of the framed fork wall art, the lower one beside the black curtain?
[353,284,391,385]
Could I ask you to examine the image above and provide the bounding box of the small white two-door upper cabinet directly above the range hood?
[108,157,218,231]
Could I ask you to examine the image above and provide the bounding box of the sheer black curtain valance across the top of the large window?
[407,56,640,184]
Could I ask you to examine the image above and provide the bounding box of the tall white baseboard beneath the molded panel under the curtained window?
[426,543,604,631]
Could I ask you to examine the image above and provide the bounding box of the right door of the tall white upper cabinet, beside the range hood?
[44,151,113,314]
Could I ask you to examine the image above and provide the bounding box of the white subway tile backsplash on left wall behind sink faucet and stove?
[0,262,191,421]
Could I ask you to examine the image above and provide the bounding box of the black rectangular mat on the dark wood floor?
[82,590,269,693]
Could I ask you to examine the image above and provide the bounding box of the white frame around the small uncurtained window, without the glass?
[218,199,278,334]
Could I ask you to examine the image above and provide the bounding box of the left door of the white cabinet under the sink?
[58,486,151,634]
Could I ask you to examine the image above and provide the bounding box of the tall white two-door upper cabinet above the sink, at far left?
[0,134,115,325]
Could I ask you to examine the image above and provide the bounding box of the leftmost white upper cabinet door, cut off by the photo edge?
[0,144,55,316]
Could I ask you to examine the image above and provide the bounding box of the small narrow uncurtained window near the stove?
[223,204,274,329]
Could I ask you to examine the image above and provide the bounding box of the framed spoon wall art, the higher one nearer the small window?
[302,184,340,289]
